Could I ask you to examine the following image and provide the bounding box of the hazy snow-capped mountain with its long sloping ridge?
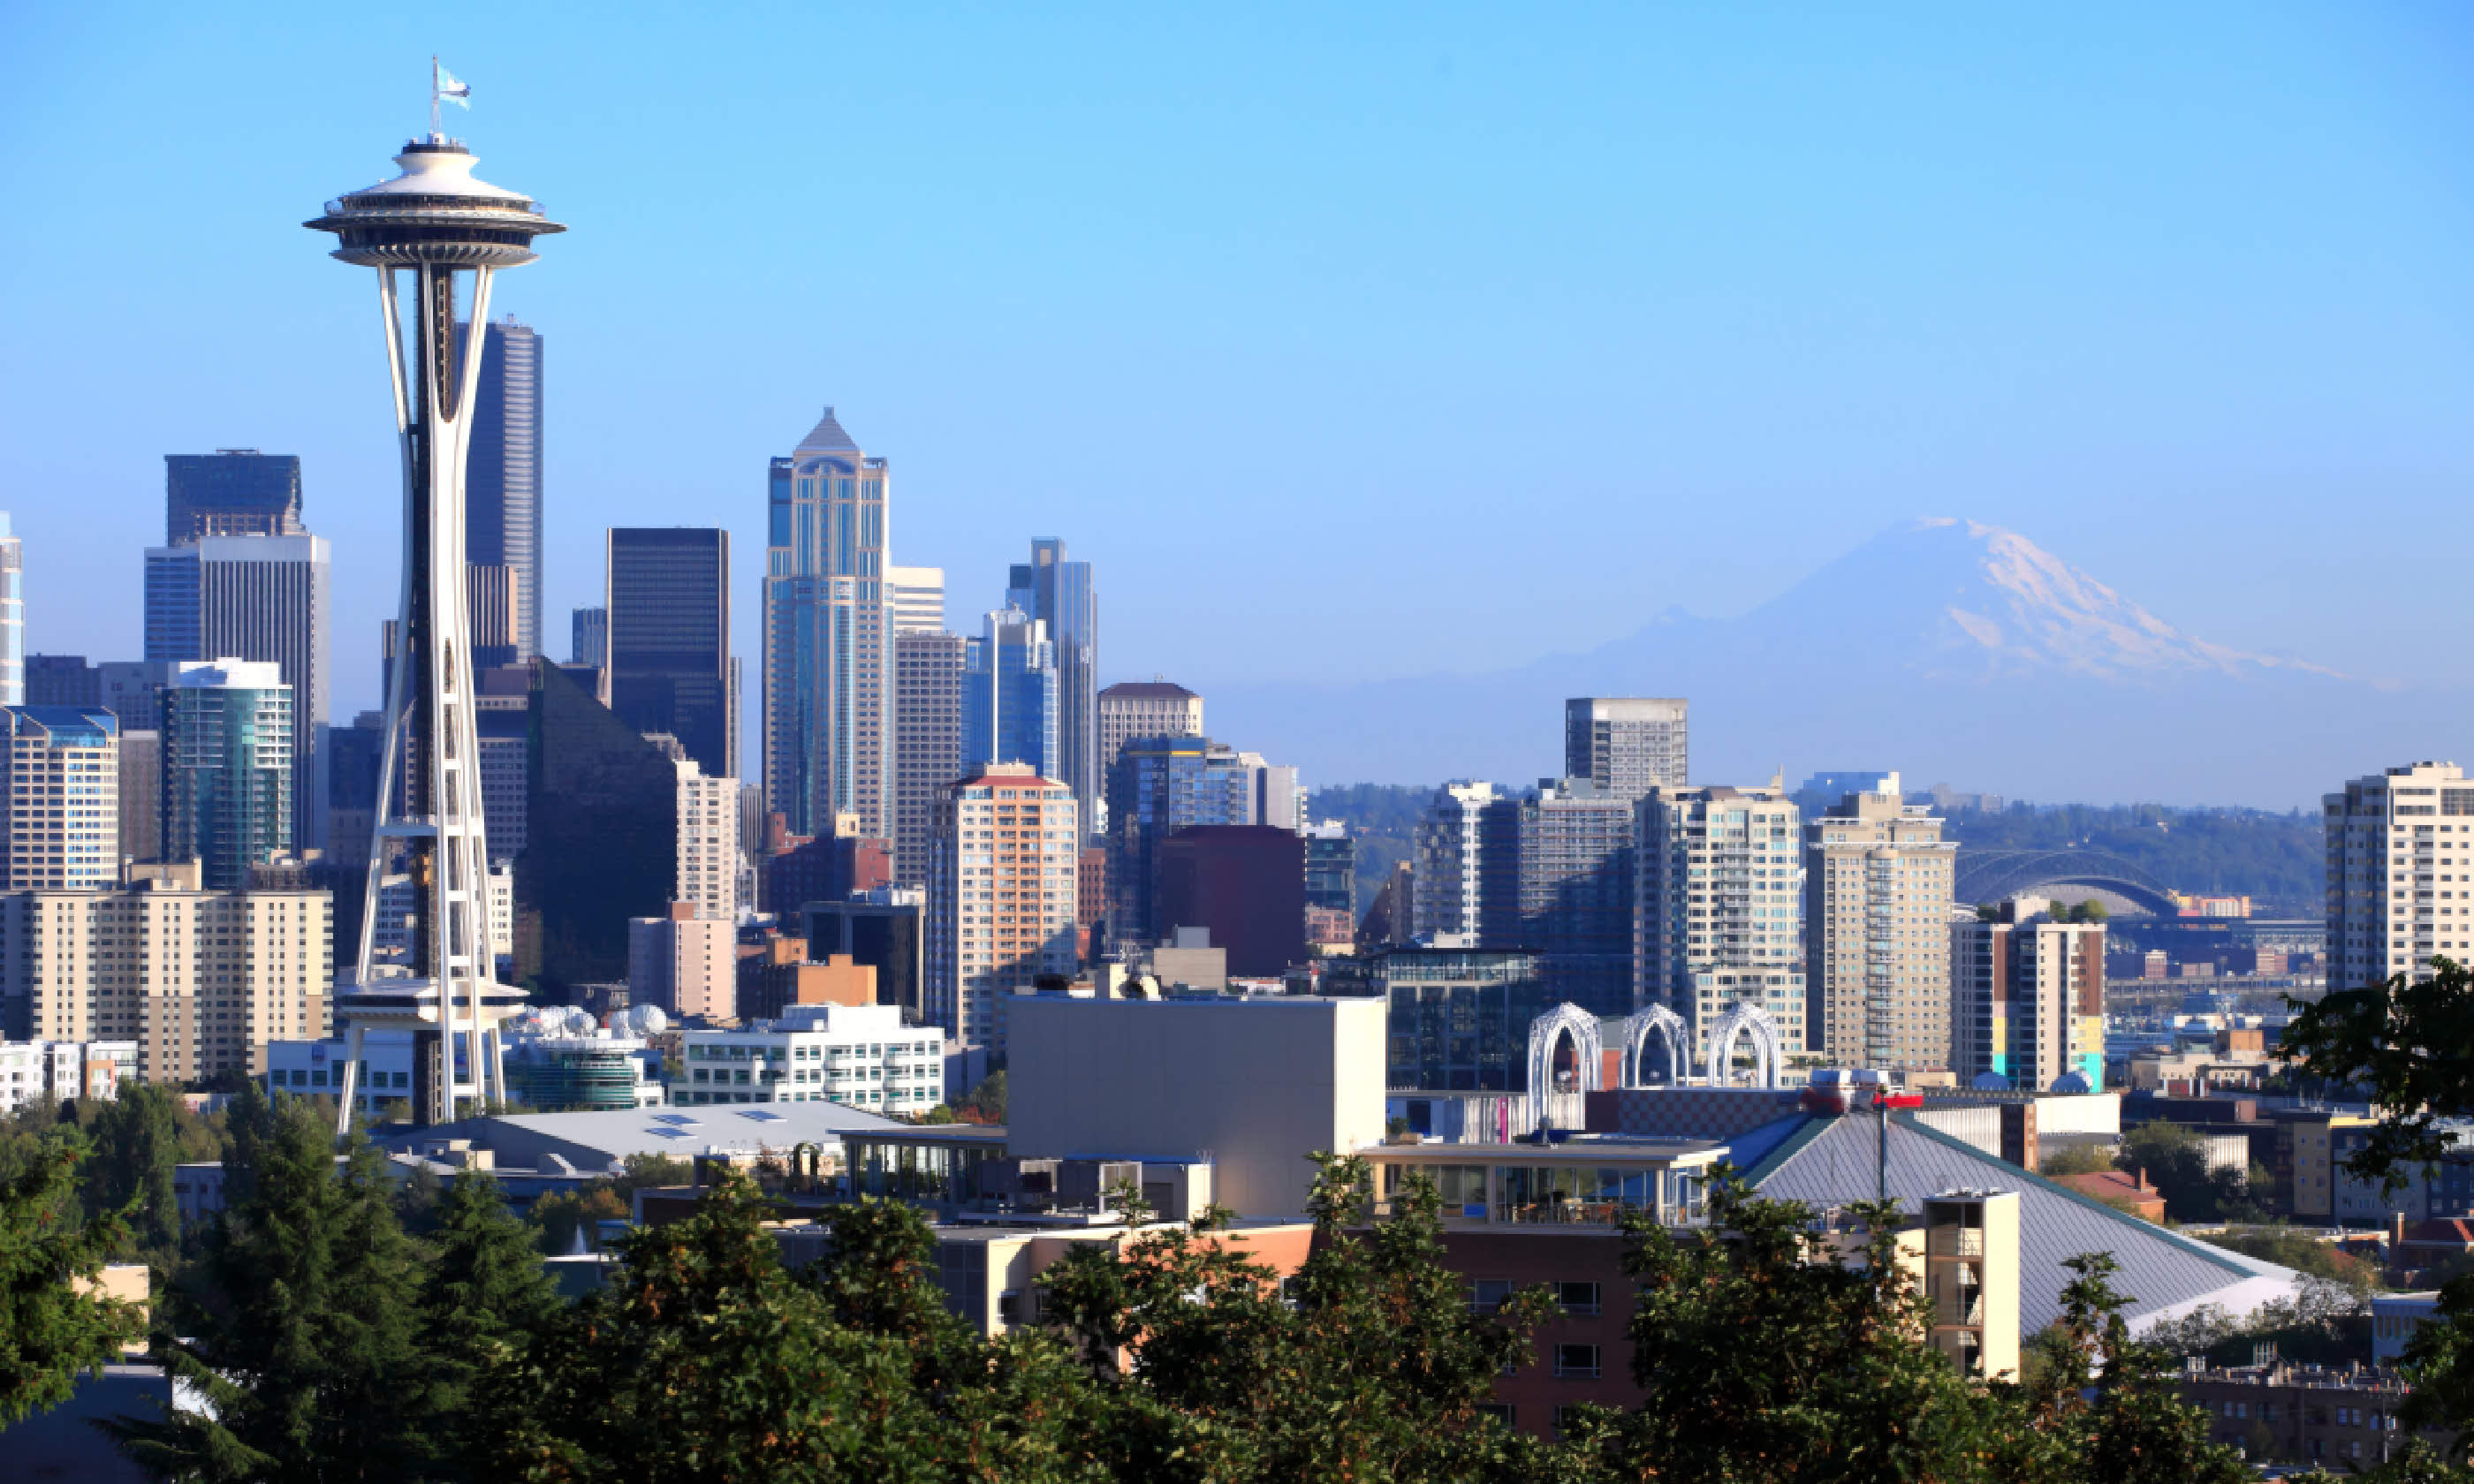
[1200,517,2434,809]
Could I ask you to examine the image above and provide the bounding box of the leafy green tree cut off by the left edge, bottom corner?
[0,1131,143,1427]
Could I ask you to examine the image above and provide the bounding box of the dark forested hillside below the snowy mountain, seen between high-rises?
[1311,784,2326,918]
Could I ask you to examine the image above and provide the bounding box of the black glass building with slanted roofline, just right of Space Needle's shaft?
[514,661,678,999]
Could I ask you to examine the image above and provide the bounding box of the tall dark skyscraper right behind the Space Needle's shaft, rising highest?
[465,314,542,661]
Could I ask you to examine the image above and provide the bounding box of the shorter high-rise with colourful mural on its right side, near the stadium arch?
[1949,903,2106,1094]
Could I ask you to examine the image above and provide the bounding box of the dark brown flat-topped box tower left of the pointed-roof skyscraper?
[603,526,740,779]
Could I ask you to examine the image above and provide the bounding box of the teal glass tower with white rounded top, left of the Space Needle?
[163,658,297,890]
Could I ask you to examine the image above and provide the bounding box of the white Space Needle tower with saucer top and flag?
[302,57,564,1132]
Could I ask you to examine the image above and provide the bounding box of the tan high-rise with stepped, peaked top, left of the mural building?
[1803,774,1960,1071]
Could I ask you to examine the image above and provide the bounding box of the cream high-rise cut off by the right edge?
[2323,761,2474,989]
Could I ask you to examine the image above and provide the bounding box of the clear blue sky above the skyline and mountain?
[0,3,2474,789]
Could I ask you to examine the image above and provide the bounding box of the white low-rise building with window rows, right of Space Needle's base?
[671,1004,945,1113]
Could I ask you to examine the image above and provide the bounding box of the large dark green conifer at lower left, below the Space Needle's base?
[109,1086,433,1481]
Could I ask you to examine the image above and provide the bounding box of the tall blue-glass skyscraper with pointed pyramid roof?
[764,408,893,838]
